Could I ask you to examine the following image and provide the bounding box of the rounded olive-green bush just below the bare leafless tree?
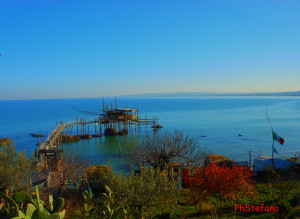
[112,167,179,218]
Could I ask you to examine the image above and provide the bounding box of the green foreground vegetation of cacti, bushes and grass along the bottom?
[1,168,300,219]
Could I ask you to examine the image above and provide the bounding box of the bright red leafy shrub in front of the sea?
[189,163,254,200]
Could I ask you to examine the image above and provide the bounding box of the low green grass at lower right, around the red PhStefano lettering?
[143,181,300,219]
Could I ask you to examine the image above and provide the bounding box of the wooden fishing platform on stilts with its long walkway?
[35,99,162,171]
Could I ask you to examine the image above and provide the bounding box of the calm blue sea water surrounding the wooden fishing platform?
[0,97,300,171]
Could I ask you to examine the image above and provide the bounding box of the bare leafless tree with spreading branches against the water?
[128,130,206,170]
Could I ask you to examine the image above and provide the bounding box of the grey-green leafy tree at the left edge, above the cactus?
[0,144,34,193]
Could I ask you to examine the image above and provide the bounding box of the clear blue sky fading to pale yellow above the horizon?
[0,0,300,100]
